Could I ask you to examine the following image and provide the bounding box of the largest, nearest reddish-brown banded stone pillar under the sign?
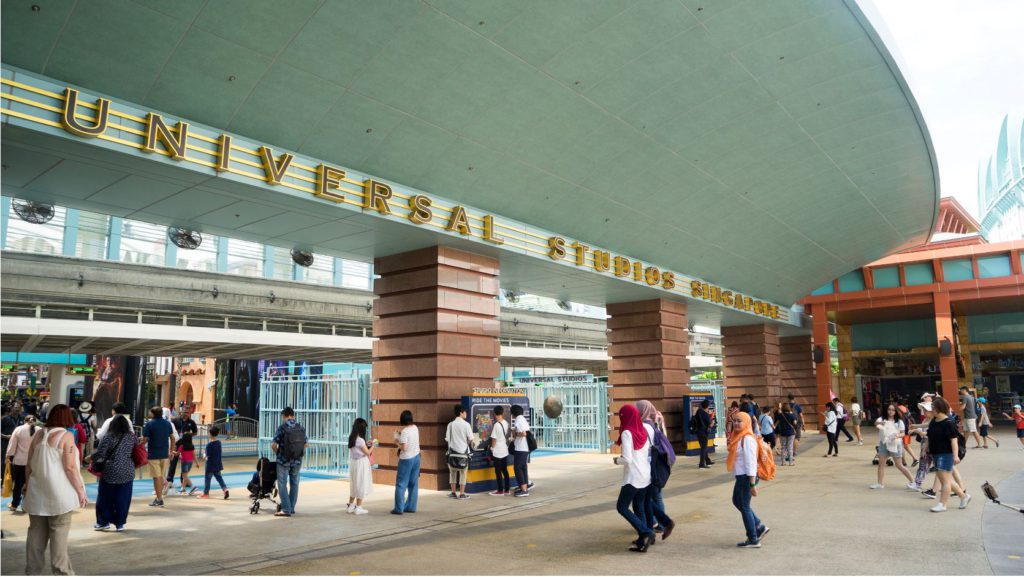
[373,247,501,490]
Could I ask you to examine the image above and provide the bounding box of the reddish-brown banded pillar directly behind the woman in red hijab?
[607,298,690,449]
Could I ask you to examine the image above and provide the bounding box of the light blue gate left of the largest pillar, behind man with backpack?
[259,373,371,477]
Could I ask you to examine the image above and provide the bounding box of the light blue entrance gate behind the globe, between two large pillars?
[509,375,608,453]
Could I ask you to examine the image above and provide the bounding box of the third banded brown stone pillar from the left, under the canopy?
[722,323,782,407]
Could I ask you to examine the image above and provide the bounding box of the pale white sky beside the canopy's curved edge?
[858,0,1024,218]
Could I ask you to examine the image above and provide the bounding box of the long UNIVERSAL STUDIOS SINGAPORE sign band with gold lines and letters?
[0,67,793,324]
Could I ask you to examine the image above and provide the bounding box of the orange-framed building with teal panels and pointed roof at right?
[800,198,1024,418]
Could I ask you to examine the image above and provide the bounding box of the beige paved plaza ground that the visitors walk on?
[0,431,1024,575]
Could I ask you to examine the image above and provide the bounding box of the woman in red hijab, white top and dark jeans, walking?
[614,405,654,553]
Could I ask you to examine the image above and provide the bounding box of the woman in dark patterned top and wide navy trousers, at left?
[92,415,138,532]
